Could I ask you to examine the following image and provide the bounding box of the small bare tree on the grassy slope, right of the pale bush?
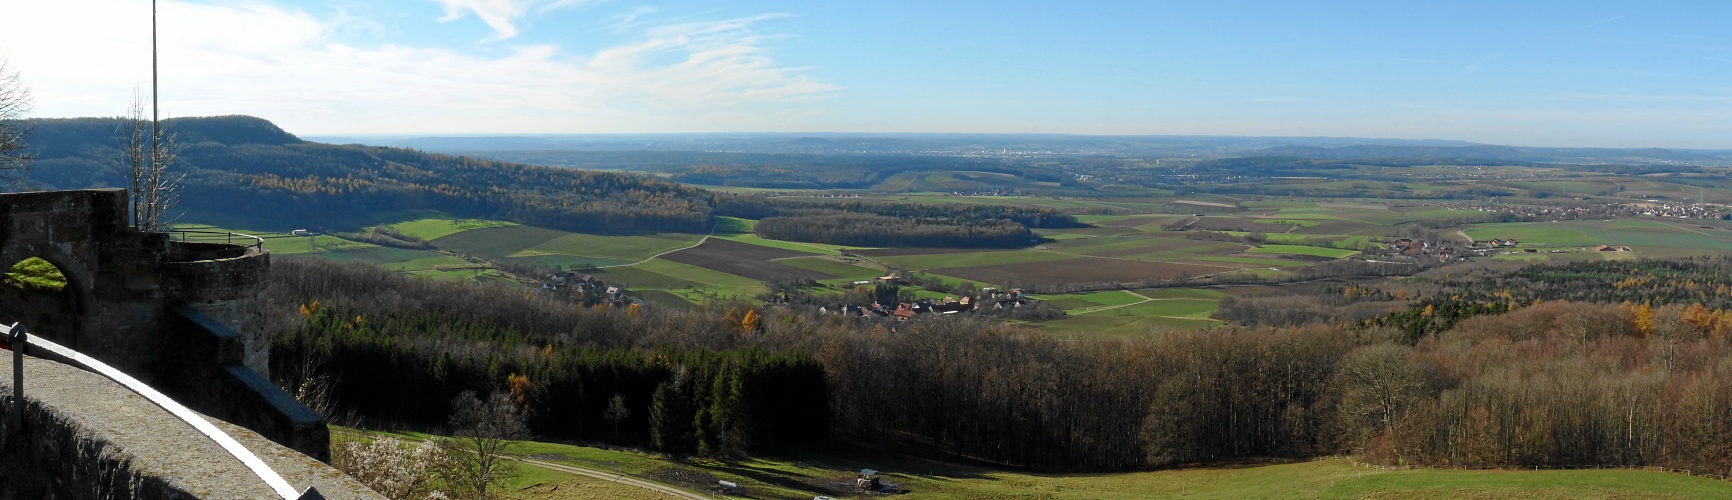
[450,391,530,500]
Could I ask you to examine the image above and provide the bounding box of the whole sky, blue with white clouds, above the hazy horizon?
[0,0,1732,149]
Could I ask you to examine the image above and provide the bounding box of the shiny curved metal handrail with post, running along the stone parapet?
[0,324,324,500]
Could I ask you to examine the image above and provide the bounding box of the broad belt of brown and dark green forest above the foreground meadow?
[268,254,1732,474]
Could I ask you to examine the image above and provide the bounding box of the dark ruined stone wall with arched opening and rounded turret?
[0,189,329,460]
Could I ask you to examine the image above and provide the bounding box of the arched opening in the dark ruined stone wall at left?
[0,258,80,343]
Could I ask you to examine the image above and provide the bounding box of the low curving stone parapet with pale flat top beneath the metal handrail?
[0,351,383,498]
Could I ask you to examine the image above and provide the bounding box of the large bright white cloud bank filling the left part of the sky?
[0,0,837,133]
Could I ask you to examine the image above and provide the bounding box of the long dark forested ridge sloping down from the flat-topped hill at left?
[29,116,1077,242]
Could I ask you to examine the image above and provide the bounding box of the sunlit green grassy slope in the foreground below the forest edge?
[344,423,1732,500]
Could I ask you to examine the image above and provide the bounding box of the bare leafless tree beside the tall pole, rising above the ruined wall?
[111,92,187,232]
